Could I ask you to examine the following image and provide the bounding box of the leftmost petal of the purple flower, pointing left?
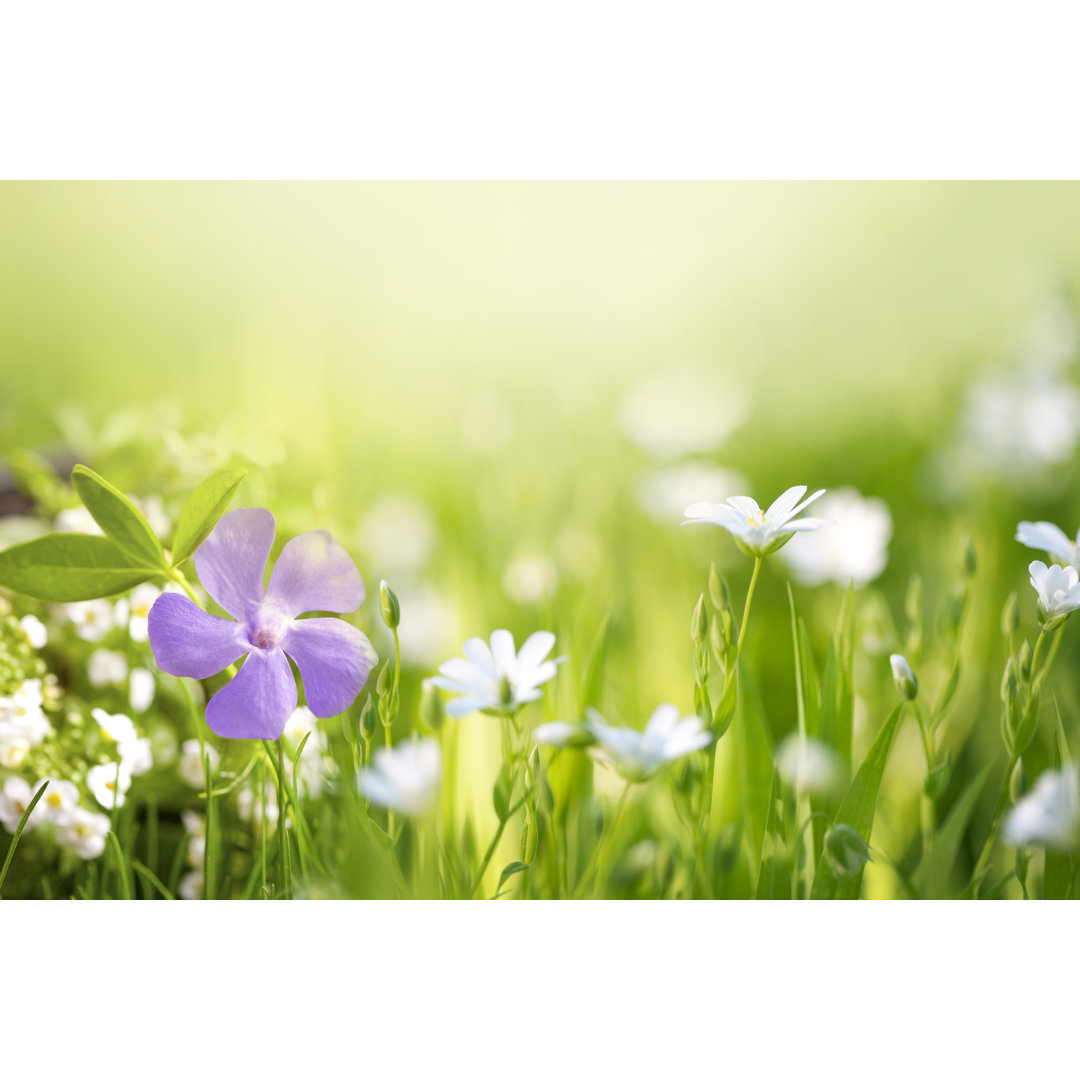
[148,593,251,678]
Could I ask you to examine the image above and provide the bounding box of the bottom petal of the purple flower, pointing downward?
[206,649,296,739]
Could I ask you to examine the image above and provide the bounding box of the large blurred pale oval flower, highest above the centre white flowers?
[619,367,750,459]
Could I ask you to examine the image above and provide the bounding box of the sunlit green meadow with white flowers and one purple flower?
[0,183,1080,900]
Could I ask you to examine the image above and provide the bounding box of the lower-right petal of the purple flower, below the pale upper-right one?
[281,619,379,717]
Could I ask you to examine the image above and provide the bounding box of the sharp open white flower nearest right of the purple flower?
[432,630,566,717]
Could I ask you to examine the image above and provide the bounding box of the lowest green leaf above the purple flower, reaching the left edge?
[0,532,161,604]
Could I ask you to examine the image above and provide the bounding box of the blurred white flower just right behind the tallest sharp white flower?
[781,487,892,585]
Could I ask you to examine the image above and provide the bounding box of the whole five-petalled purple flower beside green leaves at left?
[149,510,378,739]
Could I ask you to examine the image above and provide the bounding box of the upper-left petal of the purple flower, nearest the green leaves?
[194,510,276,621]
